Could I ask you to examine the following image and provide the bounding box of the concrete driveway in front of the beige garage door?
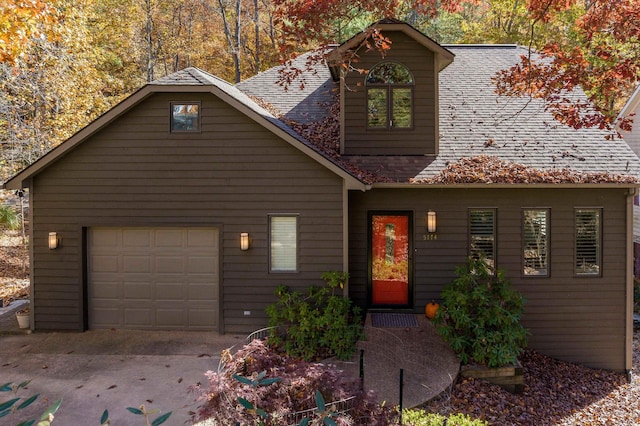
[0,330,245,426]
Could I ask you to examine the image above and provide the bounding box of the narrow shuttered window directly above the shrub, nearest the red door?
[469,209,496,269]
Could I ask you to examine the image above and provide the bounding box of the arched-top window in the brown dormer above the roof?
[366,62,413,129]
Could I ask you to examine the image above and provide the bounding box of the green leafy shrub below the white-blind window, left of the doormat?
[266,272,362,360]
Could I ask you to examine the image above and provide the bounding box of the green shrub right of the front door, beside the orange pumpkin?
[434,257,528,367]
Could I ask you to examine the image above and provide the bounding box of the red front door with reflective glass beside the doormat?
[370,213,411,307]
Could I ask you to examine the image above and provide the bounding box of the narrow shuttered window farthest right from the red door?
[575,209,602,275]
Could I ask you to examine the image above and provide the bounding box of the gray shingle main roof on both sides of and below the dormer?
[232,45,640,182]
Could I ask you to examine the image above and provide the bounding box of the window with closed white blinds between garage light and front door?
[269,216,298,272]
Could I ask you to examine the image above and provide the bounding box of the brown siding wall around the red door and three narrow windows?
[349,189,627,370]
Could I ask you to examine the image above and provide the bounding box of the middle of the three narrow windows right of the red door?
[522,209,549,277]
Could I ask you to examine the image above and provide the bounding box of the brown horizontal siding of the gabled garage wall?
[31,94,343,333]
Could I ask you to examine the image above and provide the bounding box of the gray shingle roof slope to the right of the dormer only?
[418,46,640,178]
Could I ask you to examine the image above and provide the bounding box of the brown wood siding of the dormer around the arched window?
[343,32,437,155]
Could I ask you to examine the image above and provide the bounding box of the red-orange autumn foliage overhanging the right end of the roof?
[496,0,640,130]
